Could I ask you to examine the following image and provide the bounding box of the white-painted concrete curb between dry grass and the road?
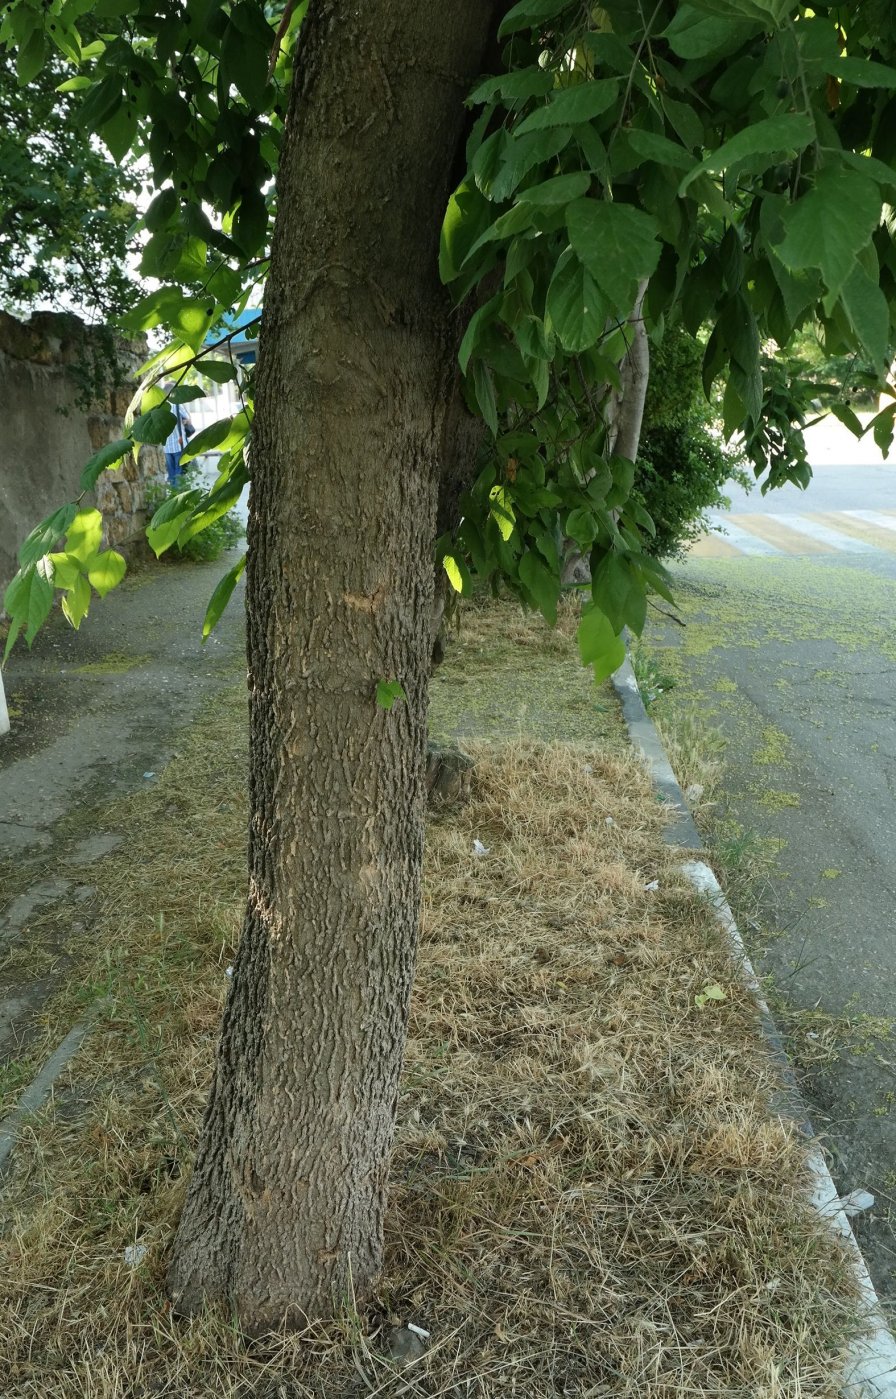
[613,658,896,1399]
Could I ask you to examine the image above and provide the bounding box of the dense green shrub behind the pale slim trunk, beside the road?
[636,329,749,558]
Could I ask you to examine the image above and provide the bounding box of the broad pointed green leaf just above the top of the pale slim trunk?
[566,199,659,316]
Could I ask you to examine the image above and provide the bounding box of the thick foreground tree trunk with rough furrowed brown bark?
[168,0,491,1333]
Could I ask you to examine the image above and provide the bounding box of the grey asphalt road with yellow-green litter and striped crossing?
[647,463,896,1300]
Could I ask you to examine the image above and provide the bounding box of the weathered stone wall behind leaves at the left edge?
[0,312,164,590]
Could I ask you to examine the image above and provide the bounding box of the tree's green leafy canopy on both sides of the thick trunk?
[0,0,896,688]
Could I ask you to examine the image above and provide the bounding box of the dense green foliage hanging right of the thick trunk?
[441,0,896,673]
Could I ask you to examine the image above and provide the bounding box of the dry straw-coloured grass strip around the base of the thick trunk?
[0,618,855,1399]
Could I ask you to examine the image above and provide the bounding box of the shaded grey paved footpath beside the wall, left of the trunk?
[0,560,245,1067]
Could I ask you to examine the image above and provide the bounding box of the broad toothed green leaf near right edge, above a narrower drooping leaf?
[776,168,881,295]
